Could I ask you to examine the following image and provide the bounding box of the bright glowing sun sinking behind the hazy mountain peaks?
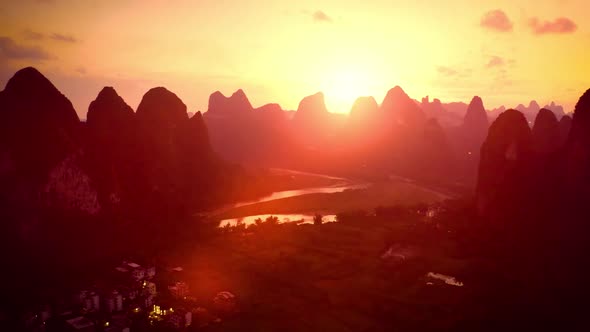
[322,66,376,113]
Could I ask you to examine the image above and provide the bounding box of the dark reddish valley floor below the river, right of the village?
[172,202,578,331]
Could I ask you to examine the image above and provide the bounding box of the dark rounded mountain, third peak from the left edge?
[136,87,225,215]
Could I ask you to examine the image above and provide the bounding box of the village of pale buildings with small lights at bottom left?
[24,261,237,332]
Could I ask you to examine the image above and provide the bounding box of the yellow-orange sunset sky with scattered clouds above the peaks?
[0,0,590,118]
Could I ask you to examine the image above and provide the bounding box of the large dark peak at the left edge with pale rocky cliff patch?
[0,67,107,218]
